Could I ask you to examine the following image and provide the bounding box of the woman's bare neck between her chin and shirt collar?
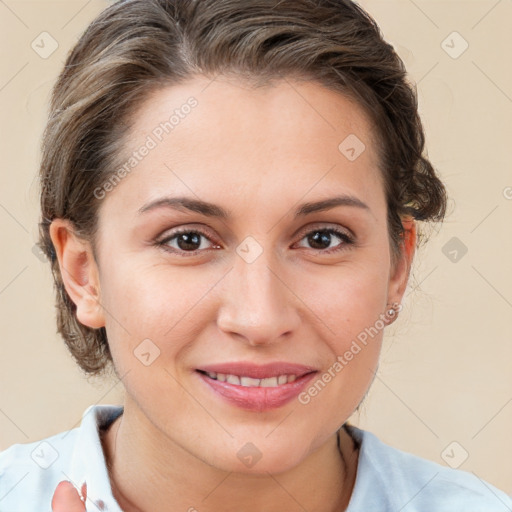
[102,400,358,512]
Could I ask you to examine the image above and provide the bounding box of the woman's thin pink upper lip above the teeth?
[197,361,317,379]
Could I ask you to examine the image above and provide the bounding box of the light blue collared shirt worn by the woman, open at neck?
[0,405,512,512]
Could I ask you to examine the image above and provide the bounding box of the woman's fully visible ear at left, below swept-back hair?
[50,219,105,329]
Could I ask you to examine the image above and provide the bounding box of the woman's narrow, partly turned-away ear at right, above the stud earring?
[388,218,416,304]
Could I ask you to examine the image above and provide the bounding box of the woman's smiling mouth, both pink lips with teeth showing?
[195,363,318,412]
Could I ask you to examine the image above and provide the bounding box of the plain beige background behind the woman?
[0,0,512,493]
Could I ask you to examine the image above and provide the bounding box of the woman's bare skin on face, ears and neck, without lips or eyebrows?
[50,77,416,512]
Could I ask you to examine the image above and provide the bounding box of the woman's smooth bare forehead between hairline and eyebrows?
[103,76,382,218]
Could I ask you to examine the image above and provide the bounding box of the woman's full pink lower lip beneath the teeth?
[196,371,316,412]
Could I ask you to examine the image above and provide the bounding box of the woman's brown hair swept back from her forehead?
[39,0,447,375]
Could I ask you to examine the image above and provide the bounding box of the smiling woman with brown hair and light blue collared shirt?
[0,0,512,512]
